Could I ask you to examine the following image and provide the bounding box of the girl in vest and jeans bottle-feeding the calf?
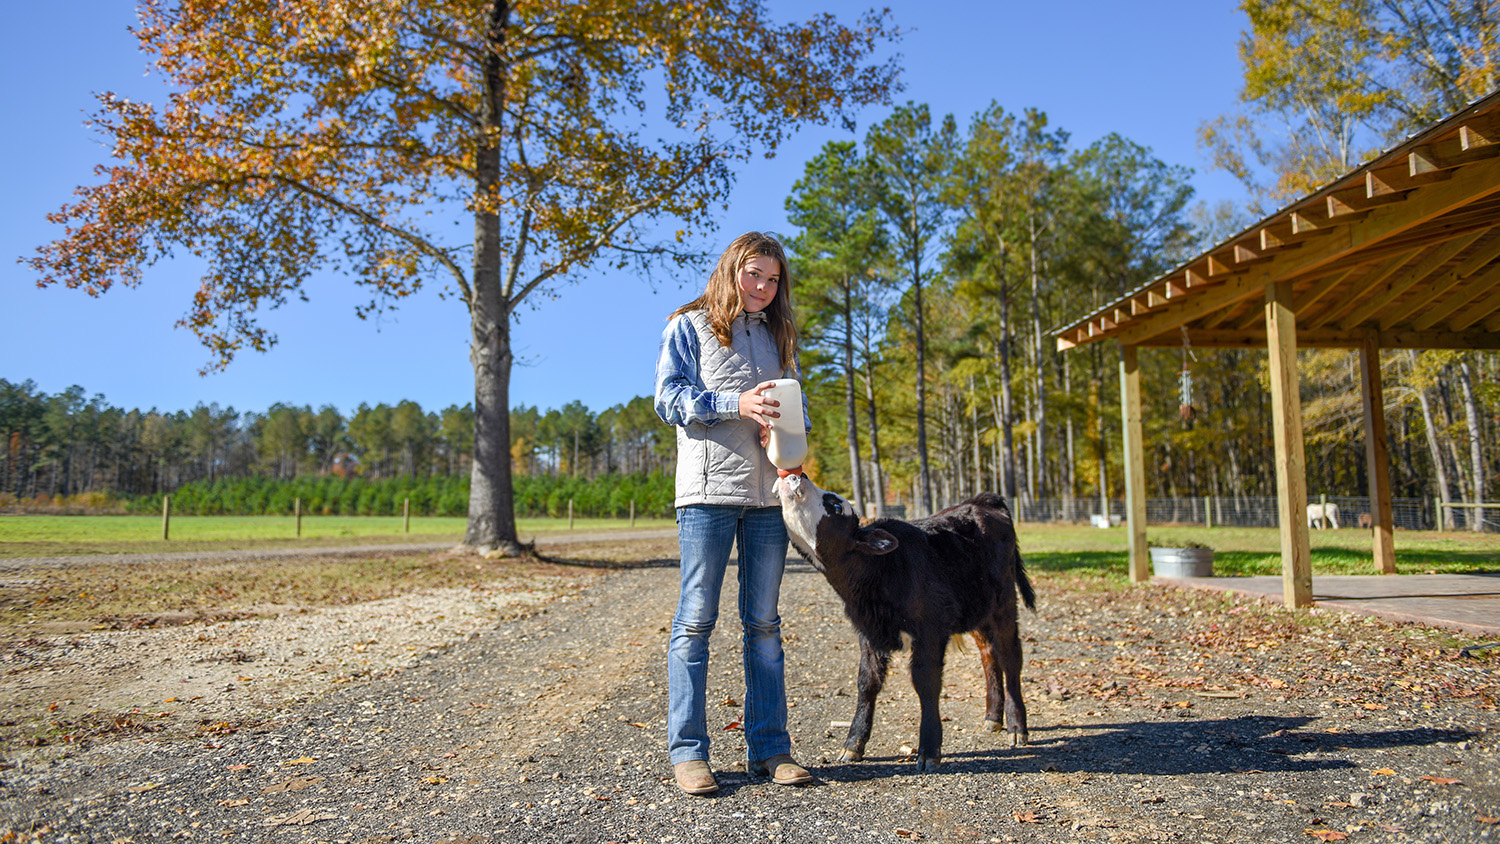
[656,232,812,795]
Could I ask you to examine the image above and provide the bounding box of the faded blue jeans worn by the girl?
[666,505,792,765]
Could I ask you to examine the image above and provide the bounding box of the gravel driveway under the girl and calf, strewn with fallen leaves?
[0,548,1500,844]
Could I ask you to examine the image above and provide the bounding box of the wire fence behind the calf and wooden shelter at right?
[885,495,1500,532]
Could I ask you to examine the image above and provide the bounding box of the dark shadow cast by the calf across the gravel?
[818,717,1475,783]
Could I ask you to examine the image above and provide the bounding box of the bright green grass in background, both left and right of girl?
[0,516,1500,576]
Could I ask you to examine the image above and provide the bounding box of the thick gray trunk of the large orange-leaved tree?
[464,0,521,553]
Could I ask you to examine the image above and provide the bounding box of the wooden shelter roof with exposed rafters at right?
[1055,93,1500,355]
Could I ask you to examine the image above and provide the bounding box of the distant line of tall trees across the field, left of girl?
[0,378,677,516]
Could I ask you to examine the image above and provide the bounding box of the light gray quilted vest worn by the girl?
[677,310,795,507]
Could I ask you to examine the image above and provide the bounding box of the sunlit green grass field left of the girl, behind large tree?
[0,516,672,559]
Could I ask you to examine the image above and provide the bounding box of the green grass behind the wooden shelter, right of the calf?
[1016,522,1500,579]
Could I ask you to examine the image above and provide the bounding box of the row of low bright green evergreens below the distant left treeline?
[129,472,674,519]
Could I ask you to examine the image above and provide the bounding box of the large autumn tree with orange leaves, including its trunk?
[29,0,897,552]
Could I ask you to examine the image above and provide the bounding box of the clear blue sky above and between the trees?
[0,0,1245,412]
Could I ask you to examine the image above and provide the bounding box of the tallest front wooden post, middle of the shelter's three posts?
[1266,282,1313,609]
